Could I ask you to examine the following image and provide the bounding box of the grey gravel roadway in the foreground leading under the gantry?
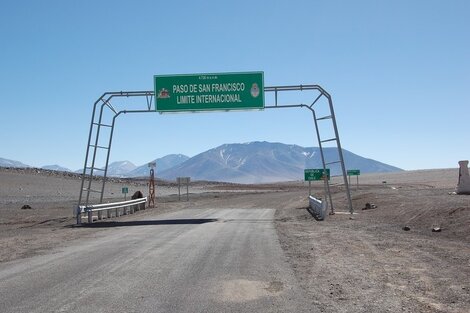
[0,208,315,313]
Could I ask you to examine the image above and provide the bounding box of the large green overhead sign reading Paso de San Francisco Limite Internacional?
[154,72,264,113]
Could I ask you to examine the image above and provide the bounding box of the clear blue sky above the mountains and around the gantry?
[0,0,470,170]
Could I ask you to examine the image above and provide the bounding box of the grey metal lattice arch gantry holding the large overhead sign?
[77,85,353,222]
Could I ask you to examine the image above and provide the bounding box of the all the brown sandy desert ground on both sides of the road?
[0,169,470,312]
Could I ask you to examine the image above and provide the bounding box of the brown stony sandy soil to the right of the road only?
[277,170,470,312]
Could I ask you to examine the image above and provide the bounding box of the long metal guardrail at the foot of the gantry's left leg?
[75,197,147,224]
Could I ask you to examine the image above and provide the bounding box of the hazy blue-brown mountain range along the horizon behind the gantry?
[0,142,401,183]
